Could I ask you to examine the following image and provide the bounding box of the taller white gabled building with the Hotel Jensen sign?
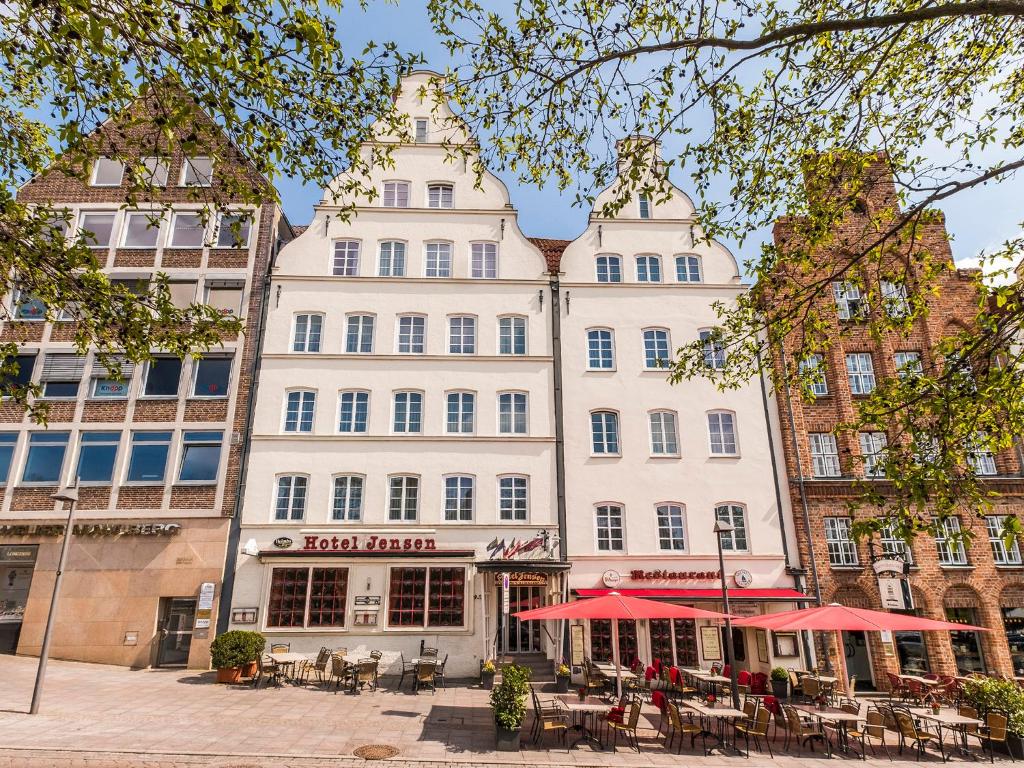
[232,73,567,676]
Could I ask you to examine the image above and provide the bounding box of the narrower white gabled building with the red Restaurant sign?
[560,143,799,672]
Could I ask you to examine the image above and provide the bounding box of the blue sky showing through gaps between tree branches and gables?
[278,0,1024,274]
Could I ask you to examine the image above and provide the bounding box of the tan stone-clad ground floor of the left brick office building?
[0,513,227,669]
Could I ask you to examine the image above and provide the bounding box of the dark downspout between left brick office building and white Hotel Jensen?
[217,207,283,635]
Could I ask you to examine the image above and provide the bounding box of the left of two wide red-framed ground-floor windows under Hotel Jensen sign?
[266,567,348,628]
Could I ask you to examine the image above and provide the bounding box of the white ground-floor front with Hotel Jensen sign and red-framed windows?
[230,526,568,677]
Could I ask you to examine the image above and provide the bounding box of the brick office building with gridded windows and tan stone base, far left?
[0,93,291,668]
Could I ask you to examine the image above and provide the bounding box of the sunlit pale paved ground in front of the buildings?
[0,655,1007,768]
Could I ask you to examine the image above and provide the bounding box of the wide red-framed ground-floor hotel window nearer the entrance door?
[387,567,466,627]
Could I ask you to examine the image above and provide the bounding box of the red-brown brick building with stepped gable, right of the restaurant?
[774,159,1024,689]
